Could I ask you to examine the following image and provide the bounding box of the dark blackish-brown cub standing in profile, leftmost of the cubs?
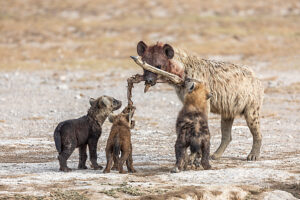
[54,96,122,172]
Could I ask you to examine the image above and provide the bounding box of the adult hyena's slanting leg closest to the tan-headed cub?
[211,116,234,160]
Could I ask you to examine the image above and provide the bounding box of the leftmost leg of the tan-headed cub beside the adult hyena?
[171,136,187,173]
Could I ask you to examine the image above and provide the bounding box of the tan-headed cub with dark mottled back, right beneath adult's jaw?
[171,81,211,173]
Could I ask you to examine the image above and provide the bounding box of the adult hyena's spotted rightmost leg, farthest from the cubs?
[244,105,262,160]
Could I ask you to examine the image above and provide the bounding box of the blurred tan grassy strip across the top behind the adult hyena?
[0,0,300,70]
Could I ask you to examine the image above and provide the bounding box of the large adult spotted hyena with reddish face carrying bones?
[137,41,264,160]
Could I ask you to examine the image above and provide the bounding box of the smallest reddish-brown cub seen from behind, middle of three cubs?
[103,106,136,173]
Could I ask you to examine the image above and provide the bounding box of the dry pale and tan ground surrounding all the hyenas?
[0,0,300,199]
